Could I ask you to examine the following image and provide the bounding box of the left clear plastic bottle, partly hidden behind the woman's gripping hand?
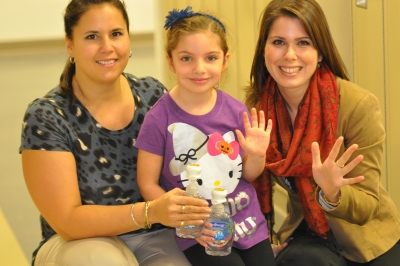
[175,164,204,239]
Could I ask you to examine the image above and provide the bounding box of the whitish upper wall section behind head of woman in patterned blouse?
[0,0,154,43]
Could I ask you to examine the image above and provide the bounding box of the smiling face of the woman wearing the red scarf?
[264,16,322,91]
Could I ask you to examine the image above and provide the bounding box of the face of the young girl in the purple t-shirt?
[167,32,229,94]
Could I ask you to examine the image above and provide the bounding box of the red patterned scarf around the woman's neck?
[253,65,339,240]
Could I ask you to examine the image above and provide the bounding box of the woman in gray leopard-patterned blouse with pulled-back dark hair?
[20,0,210,266]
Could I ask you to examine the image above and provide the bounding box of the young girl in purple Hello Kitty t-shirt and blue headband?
[136,7,275,265]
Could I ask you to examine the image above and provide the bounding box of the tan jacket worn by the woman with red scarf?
[274,78,400,263]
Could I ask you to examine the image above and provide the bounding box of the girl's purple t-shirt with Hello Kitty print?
[136,90,268,250]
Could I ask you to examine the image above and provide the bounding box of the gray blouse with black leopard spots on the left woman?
[20,73,166,258]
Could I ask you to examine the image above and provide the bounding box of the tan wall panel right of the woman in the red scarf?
[353,0,400,208]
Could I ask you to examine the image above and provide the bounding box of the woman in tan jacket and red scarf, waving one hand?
[246,0,400,266]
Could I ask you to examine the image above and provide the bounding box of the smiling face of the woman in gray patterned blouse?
[66,4,130,82]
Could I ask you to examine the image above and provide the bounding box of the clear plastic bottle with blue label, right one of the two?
[206,188,235,256]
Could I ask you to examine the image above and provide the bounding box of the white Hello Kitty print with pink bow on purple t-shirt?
[168,123,242,199]
